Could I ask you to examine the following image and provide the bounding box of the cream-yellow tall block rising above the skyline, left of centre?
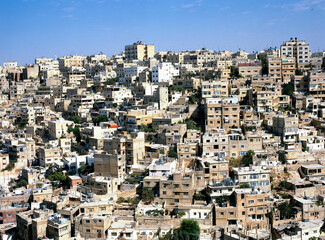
[125,41,155,61]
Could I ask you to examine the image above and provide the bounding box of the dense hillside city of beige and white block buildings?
[0,38,325,240]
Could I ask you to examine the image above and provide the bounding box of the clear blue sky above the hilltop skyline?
[0,0,325,64]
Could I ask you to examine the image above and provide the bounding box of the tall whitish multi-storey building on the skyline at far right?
[280,38,311,64]
